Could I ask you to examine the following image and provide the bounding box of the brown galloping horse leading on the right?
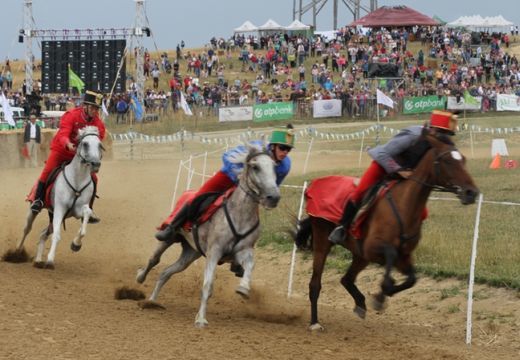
[294,132,479,330]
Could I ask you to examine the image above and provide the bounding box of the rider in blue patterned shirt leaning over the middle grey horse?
[155,124,294,241]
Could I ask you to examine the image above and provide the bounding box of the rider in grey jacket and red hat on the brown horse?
[329,110,457,244]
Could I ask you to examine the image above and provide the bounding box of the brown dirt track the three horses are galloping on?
[0,156,520,359]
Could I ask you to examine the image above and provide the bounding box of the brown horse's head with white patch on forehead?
[425,134,479,205]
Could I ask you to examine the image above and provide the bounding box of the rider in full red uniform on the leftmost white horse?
[31,90,105,222]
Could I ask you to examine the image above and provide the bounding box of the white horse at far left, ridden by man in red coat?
[16,126,104,269]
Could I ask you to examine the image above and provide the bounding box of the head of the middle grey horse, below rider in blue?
[240,144,280,209]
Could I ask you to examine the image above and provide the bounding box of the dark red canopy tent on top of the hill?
[349,5,440,27]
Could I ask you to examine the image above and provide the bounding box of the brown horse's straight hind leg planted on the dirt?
[309,231,332,331]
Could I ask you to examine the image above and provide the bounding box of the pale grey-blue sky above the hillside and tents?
[0,0,520,61]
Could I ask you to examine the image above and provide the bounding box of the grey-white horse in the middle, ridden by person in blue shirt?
[136,145,280,327]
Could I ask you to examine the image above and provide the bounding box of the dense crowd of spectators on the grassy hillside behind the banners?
[4,23,520,123]
